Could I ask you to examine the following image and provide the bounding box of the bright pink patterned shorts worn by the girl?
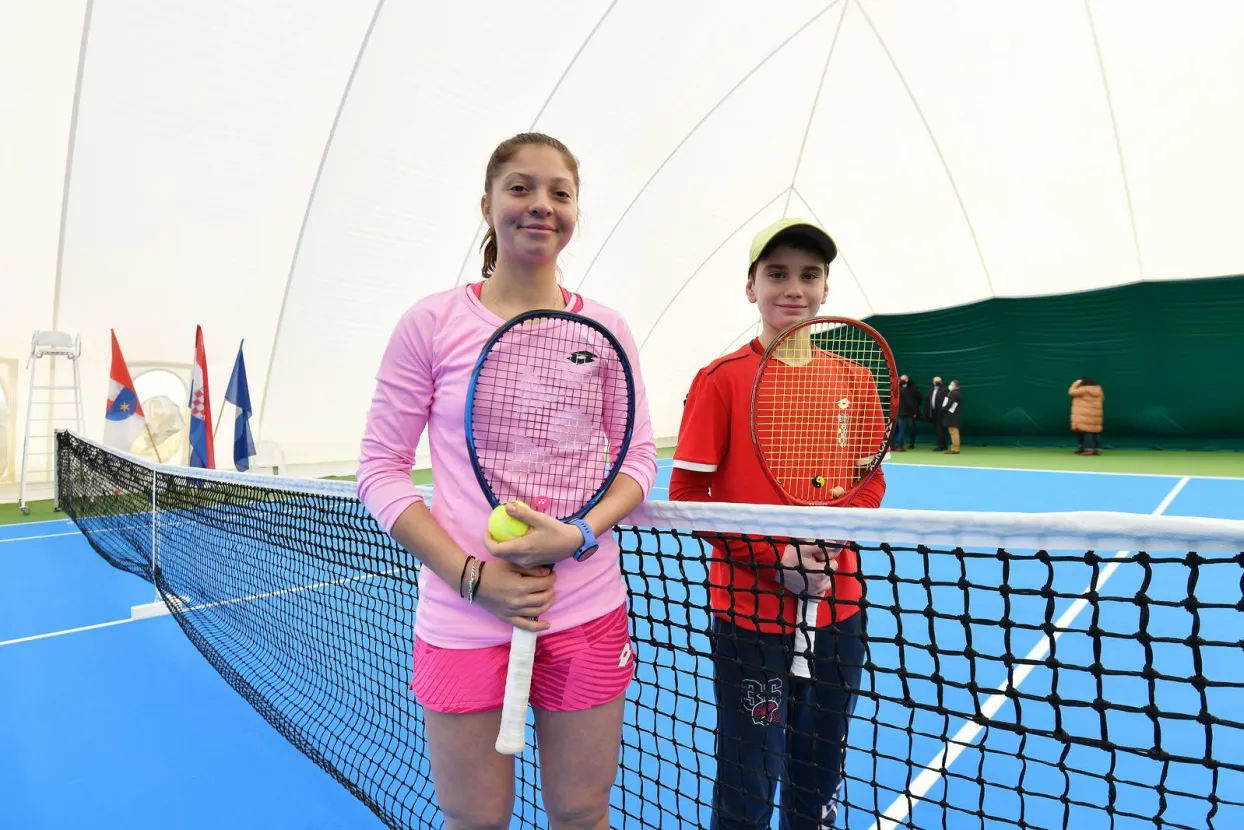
[411,604,634,714]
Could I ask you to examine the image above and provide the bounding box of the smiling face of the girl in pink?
[481,144,578,265]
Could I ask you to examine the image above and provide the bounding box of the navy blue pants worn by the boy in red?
[710,609,865,830]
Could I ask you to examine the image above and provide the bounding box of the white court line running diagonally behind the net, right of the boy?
[872,475,1191,830]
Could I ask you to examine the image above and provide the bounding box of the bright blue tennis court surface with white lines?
[0,462,1244,829]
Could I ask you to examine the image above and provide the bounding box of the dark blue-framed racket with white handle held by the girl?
[467,311,636,755]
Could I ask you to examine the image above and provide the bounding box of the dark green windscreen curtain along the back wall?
[868,276,1244,447]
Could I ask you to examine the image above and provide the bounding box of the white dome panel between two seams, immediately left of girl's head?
[260,4,617,464]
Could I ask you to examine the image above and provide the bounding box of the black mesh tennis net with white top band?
[56,432,1244,828]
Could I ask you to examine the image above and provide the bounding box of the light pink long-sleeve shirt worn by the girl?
[358,282,657,648]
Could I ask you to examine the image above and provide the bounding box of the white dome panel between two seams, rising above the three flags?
[48,0,368,447]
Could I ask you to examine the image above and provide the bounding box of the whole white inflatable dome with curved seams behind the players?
[0,0,1244,469]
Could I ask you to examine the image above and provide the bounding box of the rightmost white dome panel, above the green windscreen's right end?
[1090,0,1244,280]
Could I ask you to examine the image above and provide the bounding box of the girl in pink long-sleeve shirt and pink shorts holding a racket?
[358,133,657,828]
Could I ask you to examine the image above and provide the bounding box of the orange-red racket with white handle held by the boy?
[751,317,898,677]
